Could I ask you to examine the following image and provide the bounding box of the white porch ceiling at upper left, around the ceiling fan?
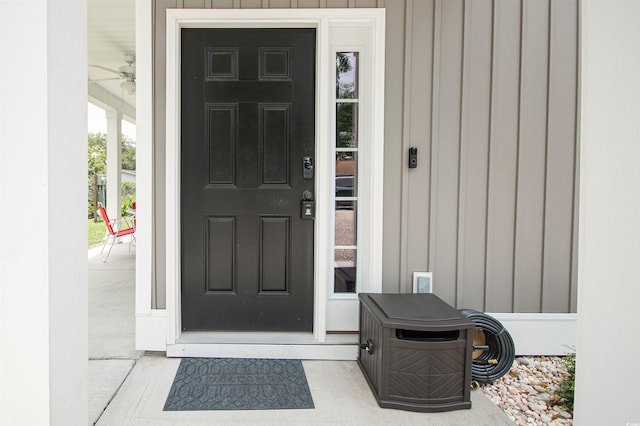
[87,0,136,122]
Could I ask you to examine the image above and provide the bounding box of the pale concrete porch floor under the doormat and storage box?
[88,243,513,426]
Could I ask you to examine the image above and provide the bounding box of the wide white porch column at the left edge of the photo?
[0,0,88,426]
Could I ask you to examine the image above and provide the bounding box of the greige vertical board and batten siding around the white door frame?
[153,0,578,312]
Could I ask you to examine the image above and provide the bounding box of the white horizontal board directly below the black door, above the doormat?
[167,343,358,361]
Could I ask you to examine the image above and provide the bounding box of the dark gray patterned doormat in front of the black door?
[164,358,314,411]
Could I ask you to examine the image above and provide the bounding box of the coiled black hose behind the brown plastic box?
[460,309,516,383]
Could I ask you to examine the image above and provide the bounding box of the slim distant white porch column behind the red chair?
[106,110,122,219]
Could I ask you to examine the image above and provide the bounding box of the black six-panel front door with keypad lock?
[180,29,315,331]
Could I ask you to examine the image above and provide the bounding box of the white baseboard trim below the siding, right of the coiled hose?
[487,312,578,355]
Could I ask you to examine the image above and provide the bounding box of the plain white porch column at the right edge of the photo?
[574,0,640,426]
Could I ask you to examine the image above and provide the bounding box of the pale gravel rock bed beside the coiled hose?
[481,356,573,426]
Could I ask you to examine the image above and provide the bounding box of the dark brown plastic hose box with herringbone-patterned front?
[358,293,475,411]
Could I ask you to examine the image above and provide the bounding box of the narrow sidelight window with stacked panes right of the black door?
[334,52,359,293]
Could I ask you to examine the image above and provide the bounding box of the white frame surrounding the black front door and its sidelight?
[166,8,385,358]
